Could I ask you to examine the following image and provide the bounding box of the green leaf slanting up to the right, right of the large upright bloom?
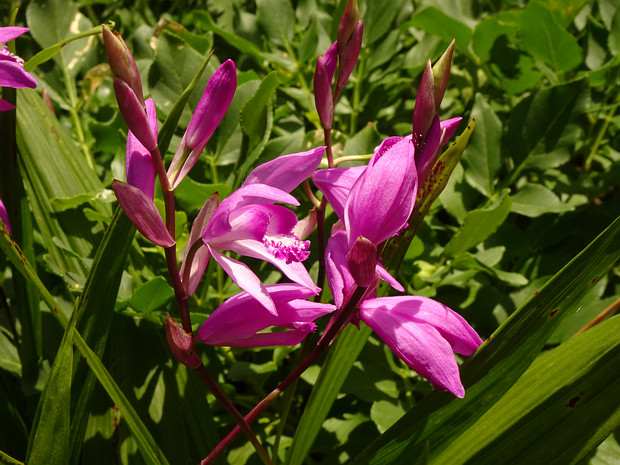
[444,189,511,257]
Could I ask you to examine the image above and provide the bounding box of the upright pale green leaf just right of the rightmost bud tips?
[463,94,502,197]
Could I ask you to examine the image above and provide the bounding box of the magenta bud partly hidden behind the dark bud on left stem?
[125,98,157,200]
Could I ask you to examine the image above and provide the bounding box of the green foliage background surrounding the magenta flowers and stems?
[0,0,620,465]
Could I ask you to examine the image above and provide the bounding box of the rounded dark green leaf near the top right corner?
[519,2,583,71]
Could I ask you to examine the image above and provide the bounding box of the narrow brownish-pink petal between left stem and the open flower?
[181,192,220,296]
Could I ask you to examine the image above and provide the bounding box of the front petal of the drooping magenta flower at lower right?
[360,299,465,397]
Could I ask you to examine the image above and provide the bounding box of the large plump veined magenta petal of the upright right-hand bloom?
[344,138,417,244]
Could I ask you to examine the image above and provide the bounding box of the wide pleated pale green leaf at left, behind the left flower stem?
[17,89,111,285]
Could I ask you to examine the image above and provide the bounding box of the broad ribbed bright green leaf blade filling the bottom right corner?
[429,317,620,465]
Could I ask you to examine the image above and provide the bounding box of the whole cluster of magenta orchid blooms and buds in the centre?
[104,1,482,397]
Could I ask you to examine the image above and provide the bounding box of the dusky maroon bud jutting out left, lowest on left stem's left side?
[112,179,175,247]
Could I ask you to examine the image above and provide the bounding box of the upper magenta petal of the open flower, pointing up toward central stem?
[243,147,325,192]
